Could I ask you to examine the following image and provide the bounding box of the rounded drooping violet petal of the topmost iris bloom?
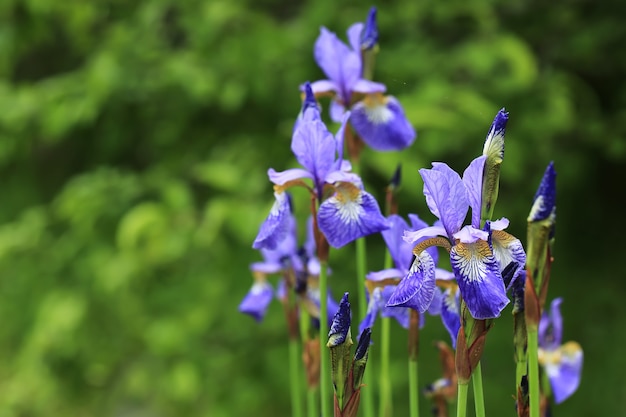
[350,94,416,151]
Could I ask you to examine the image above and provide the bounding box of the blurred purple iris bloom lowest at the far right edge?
[539,298,583,404]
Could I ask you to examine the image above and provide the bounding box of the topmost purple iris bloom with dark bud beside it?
[311,9,416,151]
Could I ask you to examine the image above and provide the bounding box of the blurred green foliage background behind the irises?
[0,0,626,417]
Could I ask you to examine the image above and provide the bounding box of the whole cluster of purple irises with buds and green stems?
[239,8,583,417]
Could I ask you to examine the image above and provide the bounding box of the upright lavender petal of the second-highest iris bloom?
[291,120,337,195]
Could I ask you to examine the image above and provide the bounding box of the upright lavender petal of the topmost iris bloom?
[314,27,361,105]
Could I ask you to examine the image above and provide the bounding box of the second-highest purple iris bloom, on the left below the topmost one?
[253,86,388,248]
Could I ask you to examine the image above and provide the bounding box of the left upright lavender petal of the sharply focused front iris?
[420,162,469,240]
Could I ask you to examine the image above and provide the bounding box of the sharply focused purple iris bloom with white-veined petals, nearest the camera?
[388,156,526,319]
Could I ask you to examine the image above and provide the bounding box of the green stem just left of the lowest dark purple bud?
[319,261,333,417]
